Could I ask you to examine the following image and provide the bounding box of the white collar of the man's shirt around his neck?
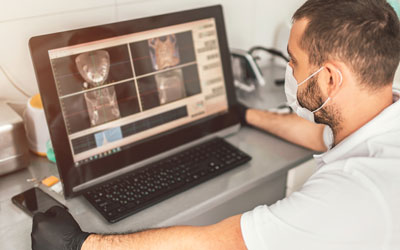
[314,90,400,167]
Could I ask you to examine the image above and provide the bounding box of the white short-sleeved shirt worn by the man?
[241,91,400,250]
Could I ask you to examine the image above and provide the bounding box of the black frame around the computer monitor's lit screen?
[29,5,239,198]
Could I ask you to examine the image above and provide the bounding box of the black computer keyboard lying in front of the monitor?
[84,138,251,223]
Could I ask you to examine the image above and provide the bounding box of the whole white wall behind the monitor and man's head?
[0,0,304,101]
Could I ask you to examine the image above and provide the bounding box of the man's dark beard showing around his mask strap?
[297,78,342,135]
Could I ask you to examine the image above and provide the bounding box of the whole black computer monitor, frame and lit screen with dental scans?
[29,6,239,198]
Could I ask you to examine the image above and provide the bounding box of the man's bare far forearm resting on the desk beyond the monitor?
[245,109,327,152]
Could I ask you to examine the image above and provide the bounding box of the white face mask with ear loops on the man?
[285,63,343,122]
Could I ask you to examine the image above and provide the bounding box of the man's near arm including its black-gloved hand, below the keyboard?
[31,206,246,250]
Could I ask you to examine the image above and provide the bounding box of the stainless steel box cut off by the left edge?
[0,102,30,175]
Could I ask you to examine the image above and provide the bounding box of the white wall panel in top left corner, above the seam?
[0,0,115,22]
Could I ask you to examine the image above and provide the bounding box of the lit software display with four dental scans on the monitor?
[49,18,228,166]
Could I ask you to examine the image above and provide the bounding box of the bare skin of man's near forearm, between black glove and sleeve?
[82,215,246,250]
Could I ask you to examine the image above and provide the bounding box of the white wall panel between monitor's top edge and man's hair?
[117,0,305,49]
